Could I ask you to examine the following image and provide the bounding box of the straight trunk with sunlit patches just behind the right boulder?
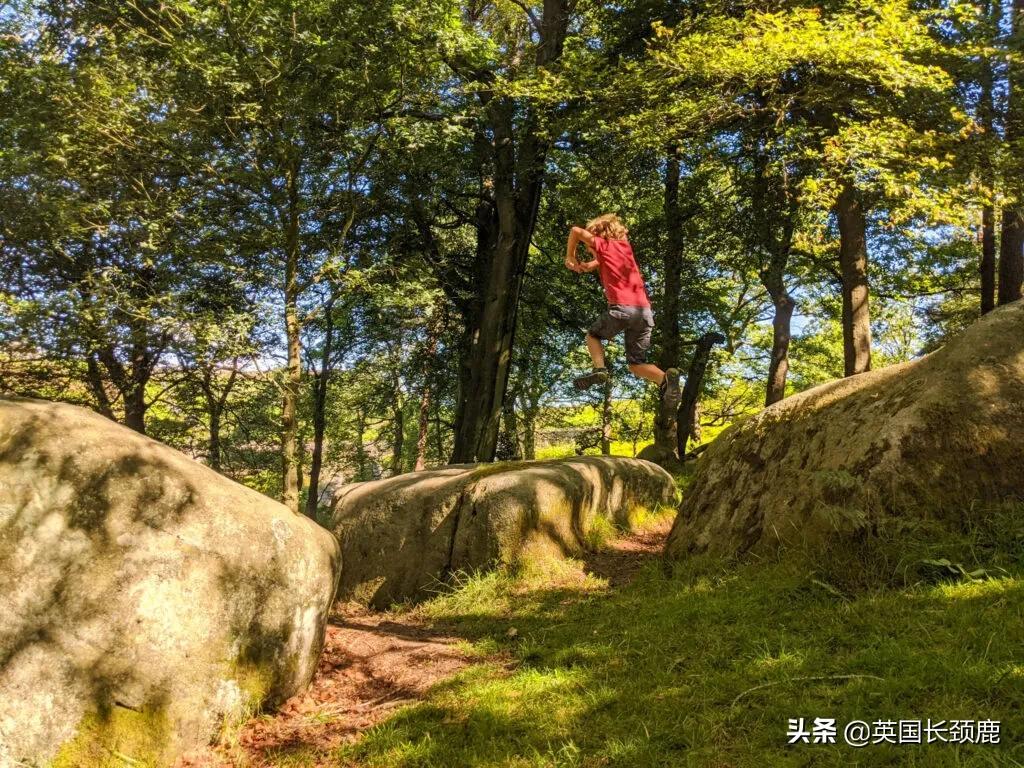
[836,182,871,376]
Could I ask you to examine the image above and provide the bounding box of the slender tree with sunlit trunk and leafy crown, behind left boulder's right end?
[118,0,434,511]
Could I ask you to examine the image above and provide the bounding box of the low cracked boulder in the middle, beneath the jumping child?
[329,456,675,607]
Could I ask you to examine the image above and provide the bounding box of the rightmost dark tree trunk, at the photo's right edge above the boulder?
[999,0,1024,305]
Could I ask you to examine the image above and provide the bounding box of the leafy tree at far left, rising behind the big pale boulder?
[0,4,205,432]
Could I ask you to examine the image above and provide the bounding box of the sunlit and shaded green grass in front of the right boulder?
[282,510,1024,768]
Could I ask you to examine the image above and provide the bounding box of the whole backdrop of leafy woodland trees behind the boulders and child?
[0,0,1024,514]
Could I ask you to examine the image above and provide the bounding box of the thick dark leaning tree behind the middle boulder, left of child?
[432,0,571,463]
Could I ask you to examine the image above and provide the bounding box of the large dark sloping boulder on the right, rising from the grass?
[667,301,1024,557]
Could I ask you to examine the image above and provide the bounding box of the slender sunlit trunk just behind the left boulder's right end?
[281,159,302,513]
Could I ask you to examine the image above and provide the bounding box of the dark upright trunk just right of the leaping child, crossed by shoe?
[654,146,683,456]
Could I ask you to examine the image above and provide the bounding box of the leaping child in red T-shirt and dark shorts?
[565,213,679,408]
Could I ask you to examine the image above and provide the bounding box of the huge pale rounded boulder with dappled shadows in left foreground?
[0,399,340,766]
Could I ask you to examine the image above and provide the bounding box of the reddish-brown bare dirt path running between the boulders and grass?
[176,521,671,768]
